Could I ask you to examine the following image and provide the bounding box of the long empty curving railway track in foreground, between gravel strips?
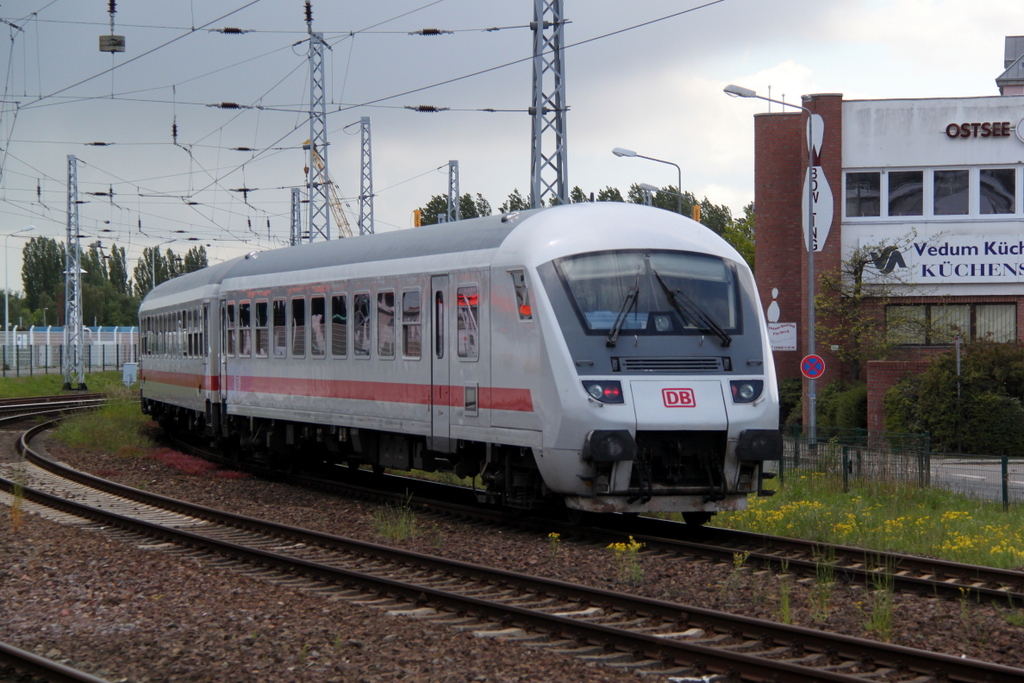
[8,423,1024,683]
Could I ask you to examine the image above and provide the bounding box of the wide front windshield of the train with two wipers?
[555,251,741,344]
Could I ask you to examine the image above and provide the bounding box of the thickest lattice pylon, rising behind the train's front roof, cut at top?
[529,0,568,209]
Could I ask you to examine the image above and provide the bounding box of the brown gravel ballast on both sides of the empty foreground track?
[0,436,1024,683]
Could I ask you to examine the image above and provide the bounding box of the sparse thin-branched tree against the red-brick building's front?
[814,236,913,381]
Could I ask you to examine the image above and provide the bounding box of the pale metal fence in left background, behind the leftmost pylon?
[0,326,138,377]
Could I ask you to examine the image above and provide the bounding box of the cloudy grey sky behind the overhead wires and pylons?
[0,0,1024,290]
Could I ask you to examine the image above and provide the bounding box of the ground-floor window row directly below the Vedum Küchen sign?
[886,303,1017,346]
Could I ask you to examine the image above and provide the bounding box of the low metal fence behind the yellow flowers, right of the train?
[777,430,1024,508]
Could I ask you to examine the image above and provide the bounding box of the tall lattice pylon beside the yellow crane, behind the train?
[307,31,331,242]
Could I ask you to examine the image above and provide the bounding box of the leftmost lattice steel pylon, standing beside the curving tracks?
[63,155,86,391]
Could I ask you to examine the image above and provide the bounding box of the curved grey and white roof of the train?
[142,202,741,309]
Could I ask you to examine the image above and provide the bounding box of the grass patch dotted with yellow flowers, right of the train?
[715,473,1024,568]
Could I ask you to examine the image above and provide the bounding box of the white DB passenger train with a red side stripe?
[139,203,781,523]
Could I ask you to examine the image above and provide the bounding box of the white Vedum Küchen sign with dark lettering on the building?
[860,234,1024,285]
